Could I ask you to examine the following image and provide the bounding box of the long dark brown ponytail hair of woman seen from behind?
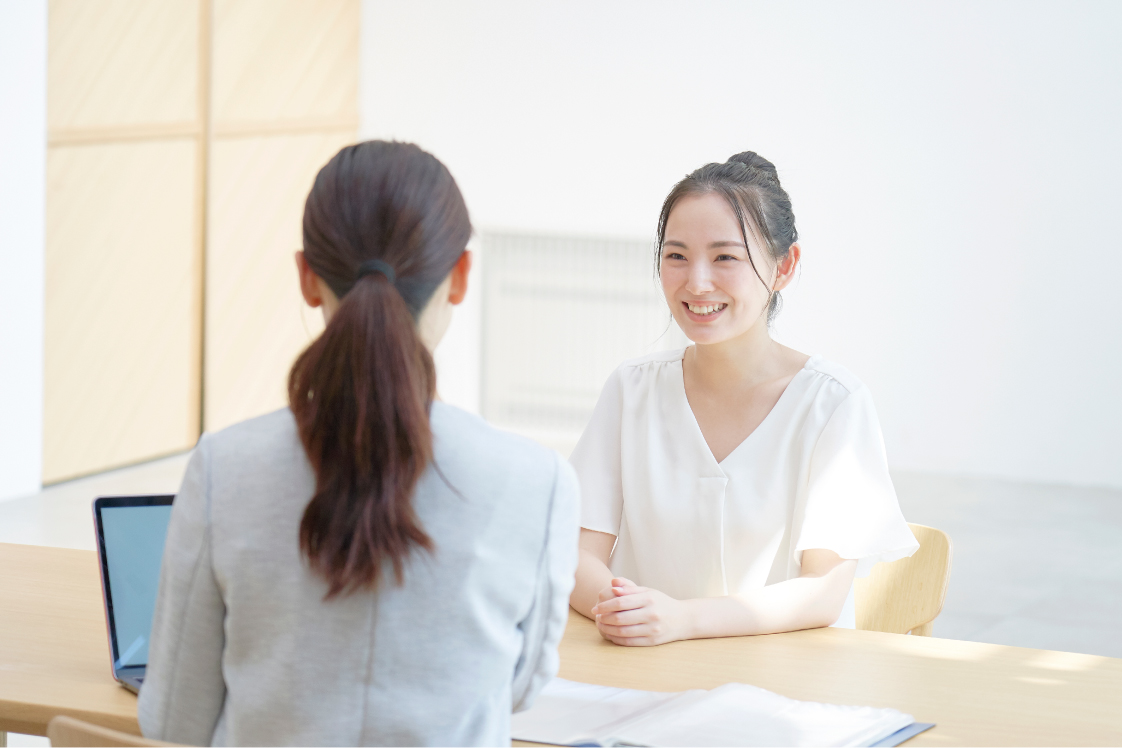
[288,140,471,598]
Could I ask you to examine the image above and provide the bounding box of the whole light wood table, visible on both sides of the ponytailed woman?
[0,544,1122,746]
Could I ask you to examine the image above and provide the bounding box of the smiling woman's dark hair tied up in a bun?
[654,150,799,324]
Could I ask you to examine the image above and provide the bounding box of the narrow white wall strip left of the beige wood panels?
[0,0,47,499]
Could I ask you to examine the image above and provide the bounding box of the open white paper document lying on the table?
[511,678,914,746]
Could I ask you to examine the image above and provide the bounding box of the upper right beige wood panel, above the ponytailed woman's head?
[211,0,359,128]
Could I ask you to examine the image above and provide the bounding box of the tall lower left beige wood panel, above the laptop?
[43,140,201,482]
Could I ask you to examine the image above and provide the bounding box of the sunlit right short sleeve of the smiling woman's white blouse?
[794,386,919,576]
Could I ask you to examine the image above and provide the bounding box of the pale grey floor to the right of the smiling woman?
[893,472,1122,657]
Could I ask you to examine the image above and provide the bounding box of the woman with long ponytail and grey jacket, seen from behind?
[139,141,578,746]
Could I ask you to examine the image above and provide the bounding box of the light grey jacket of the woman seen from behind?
[139,403,578,745]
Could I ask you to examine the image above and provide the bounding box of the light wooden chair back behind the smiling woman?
[854,523,951,636]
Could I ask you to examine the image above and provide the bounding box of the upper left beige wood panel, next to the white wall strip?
[47,0,201,137]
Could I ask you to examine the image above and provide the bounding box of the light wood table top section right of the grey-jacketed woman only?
[559,610,1122,746]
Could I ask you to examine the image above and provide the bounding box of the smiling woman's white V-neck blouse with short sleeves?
[571,349,919,628]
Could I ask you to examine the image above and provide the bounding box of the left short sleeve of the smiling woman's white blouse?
[569,369,624,536]
